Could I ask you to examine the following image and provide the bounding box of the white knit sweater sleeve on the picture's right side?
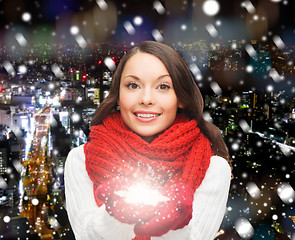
[151,156,231,240]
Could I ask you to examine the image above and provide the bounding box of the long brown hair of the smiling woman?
[90,41,231,169]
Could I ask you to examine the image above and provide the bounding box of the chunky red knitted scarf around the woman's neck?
[84,112,214,240]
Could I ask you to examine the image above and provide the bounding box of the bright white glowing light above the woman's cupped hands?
[115,183,169,206]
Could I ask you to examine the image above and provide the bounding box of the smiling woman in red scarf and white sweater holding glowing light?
[65,41,231,240]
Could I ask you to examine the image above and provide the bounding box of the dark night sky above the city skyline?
[0,0,295,44]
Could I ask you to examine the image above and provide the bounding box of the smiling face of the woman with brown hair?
[118,52,182,142]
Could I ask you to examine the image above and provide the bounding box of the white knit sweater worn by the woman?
[64,145,231,240]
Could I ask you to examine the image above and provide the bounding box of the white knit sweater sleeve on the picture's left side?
[64,145,135,240]
